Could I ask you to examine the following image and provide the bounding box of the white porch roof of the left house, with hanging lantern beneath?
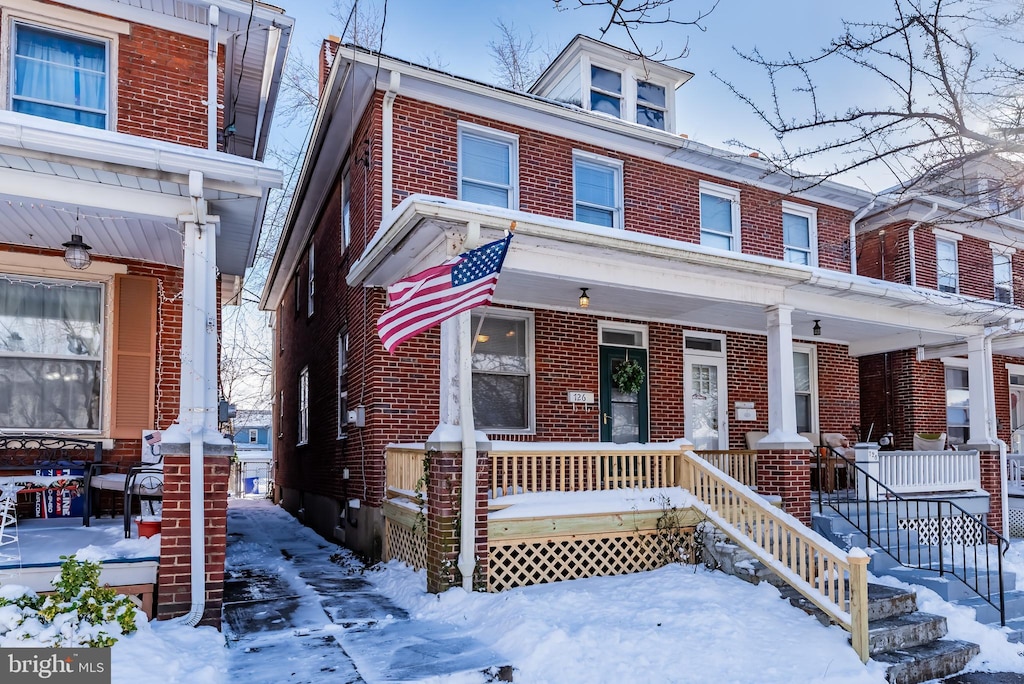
[0,112,282,275]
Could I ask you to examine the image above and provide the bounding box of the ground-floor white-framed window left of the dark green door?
[472,309,534,432]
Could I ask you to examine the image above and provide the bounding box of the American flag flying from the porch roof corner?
[377,232,512,353]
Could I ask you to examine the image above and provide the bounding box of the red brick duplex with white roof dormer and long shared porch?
[262,36,1024,556]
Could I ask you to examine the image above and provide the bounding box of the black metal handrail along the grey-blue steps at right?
[814,446,1010,625]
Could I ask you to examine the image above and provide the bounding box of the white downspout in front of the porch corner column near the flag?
[458,311,476,592]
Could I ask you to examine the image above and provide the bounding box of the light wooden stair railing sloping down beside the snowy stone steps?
[680,453,869,662]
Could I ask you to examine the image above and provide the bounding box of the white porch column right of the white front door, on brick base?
[760,305,810,448]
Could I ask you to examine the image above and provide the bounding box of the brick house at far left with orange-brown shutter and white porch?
[0,0,293,624]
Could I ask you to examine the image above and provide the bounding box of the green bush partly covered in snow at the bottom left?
[0,555,137,648]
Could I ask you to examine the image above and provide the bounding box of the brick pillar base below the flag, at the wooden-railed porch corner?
[427,442,490,594]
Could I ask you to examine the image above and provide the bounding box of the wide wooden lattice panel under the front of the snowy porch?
[487,528,696,592]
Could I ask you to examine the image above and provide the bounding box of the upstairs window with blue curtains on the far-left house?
[9,22,111,128]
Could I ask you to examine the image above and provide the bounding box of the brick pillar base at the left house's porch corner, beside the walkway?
[157,442,233,629]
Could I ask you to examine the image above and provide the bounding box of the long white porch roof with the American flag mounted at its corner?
[348,196,1024,356]
